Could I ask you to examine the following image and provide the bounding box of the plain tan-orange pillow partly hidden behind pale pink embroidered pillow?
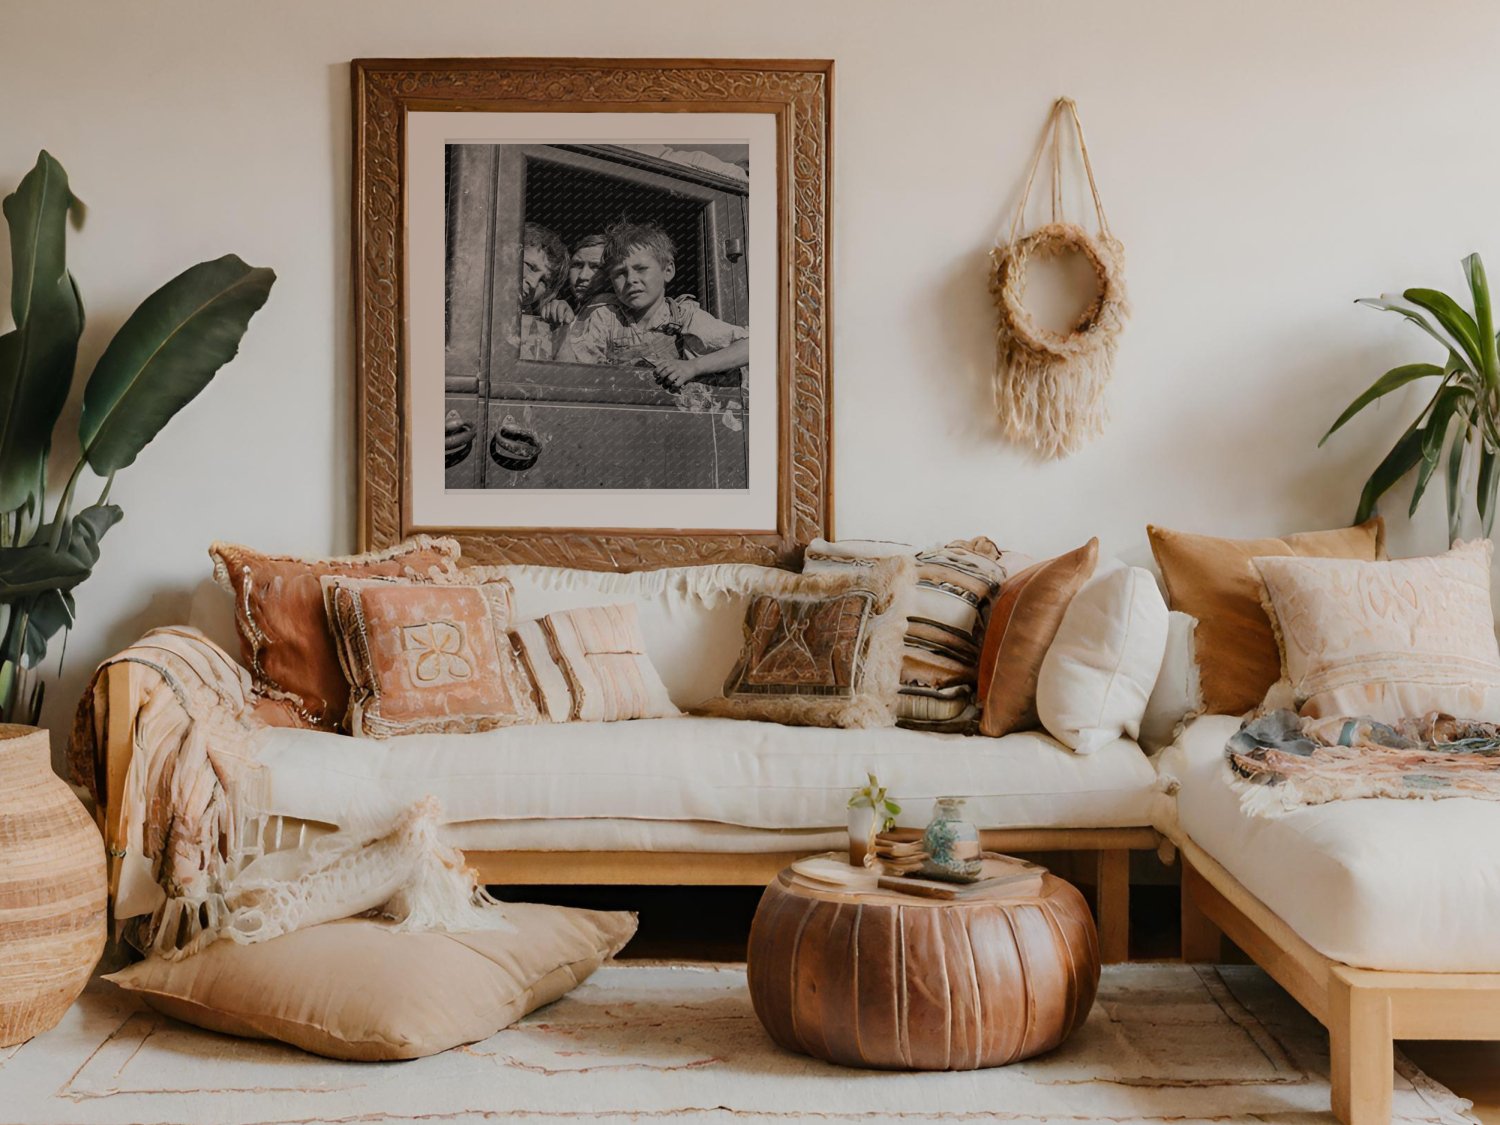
[1146,516,1386,716]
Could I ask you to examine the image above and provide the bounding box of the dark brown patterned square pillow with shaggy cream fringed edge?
[704,555,917,728]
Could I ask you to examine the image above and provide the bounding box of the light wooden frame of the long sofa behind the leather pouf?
[98,662,1161,963]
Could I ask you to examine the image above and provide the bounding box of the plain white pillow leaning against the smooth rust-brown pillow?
[1037,564,1167,755]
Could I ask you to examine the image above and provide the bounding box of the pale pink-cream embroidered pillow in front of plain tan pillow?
[1254,540,1500,723]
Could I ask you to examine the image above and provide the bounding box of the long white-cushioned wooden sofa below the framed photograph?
[96,566,1160,962]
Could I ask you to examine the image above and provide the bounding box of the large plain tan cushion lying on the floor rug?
[105,903,636,1062]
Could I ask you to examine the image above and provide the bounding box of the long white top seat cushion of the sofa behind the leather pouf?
[254,717,1157,828]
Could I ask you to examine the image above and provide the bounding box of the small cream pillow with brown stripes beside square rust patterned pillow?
[512,602,683,723]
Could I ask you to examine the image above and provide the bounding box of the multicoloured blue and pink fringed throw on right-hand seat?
[1224,711,1500,816]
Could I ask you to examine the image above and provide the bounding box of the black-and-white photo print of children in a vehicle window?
[444,140,750,491]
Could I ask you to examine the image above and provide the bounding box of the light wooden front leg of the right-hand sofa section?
[1328,969,1395,1125]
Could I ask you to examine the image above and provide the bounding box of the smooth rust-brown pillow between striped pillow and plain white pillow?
[980,539,1100,738]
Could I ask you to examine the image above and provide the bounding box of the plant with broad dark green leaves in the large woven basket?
[0,152,276,725]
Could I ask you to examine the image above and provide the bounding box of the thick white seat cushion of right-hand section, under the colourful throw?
[1158,716,1500,972]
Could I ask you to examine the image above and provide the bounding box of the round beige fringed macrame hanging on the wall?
[990,98,1130,461]
